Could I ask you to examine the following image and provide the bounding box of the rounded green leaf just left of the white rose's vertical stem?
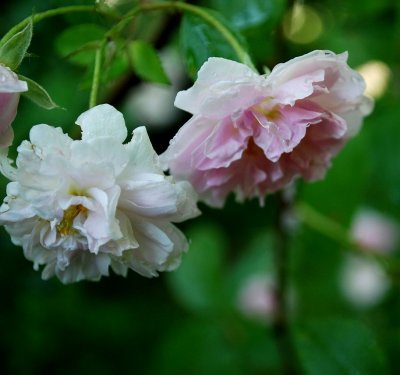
[55,24,107,66]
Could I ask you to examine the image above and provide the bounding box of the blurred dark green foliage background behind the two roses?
[0,0,400,375]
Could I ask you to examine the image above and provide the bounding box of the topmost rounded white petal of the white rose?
[76,104,128,143]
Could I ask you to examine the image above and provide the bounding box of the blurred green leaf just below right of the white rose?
[168,225,226,311]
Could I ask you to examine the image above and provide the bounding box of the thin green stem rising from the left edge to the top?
[1,5,115,47]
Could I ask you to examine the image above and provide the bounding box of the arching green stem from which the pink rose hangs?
[109,1,256,71]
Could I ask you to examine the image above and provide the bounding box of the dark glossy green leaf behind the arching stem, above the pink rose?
[179,10,250,79]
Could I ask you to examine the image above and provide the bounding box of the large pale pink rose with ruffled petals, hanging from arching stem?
[161,51,372,207]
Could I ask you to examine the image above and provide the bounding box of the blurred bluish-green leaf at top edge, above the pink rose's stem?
[212,0,286,30]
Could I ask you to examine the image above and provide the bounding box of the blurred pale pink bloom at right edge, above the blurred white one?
[350,209,400,252]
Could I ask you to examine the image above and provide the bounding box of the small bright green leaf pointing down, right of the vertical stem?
[129,40,170,84]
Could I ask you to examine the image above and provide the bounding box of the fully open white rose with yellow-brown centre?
[0,104,199,283]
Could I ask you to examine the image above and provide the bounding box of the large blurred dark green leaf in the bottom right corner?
[295,318,388,375]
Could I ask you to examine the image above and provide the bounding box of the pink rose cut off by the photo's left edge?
[0,65,28,148]
